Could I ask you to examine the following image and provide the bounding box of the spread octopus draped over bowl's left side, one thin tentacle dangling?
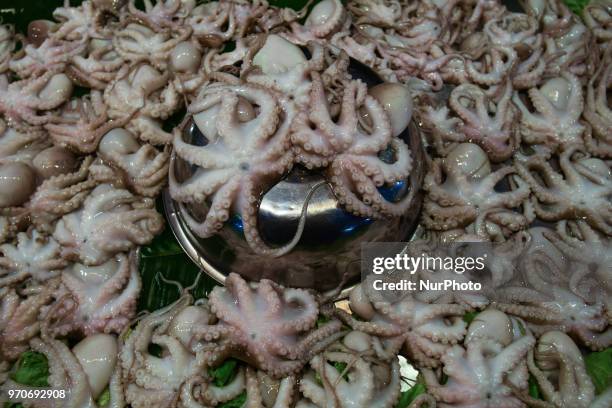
[169,83,306,256]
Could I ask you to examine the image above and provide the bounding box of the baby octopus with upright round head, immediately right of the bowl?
[423,143,529,239]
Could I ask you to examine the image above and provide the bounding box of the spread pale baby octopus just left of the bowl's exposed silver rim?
[53,184,163,265]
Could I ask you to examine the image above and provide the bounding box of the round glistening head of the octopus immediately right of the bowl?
[444,143,491,179]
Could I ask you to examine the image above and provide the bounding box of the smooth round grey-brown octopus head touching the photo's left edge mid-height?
[0,162,36,207]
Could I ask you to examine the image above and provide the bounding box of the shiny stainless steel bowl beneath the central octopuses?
[164,62,426,291]
